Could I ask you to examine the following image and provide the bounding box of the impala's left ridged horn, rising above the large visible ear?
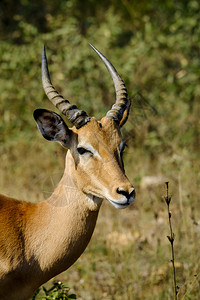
[42,46,90,129]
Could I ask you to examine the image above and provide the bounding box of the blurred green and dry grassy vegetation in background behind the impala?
[0,0,200,300]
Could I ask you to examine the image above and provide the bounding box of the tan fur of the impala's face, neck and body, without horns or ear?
[0,117,133,300]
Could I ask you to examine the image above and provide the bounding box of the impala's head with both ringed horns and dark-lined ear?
[34,45,135,209]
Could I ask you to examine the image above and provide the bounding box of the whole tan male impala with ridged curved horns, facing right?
[0,45,134,300]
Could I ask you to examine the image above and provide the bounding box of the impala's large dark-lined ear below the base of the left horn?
[33,109,72,148]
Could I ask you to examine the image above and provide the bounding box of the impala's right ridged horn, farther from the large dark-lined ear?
[89,44,130,126]
